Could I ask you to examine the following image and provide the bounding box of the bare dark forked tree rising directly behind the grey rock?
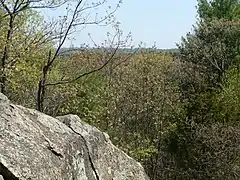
[37,21,129,111]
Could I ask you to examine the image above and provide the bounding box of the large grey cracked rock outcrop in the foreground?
[0,93,148,180]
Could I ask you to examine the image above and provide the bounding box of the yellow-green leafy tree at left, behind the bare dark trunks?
[0,9,53,108]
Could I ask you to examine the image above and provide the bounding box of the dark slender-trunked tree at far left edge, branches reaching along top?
[0,0,66,93]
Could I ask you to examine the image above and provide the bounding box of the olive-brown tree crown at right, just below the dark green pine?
[178,20,240,92]
